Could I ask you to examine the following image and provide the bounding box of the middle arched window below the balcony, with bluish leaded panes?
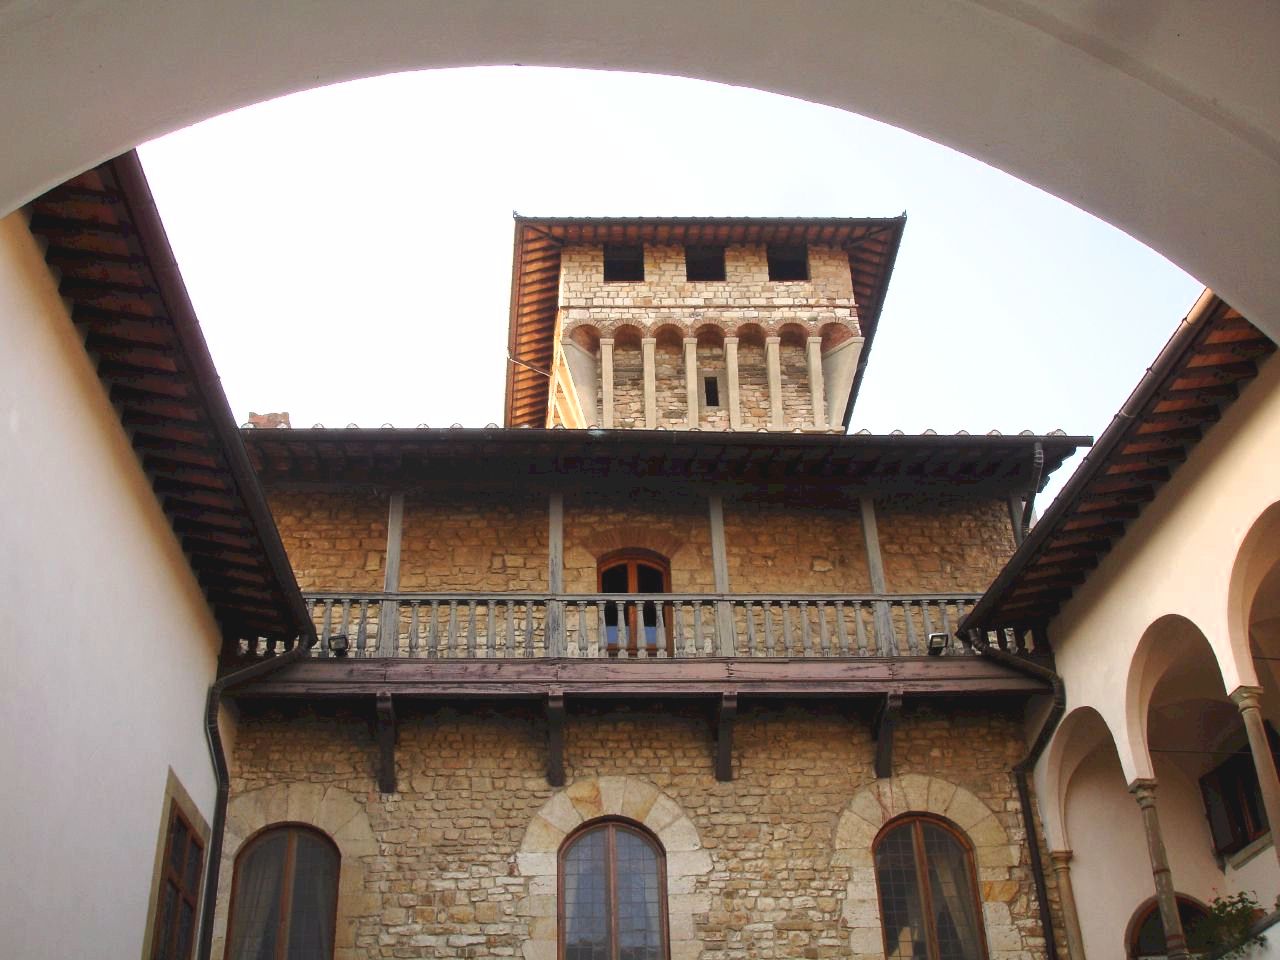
[559,820,669,960]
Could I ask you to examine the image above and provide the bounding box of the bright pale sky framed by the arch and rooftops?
[140,67,1202,504]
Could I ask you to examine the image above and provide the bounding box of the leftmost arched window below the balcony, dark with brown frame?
[227,824,339,960]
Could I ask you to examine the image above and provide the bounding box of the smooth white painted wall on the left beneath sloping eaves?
[0,214,219,960]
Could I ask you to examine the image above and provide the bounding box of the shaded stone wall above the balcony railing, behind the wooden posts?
[270,489,1014,594]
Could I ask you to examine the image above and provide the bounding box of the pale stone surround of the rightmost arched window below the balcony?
[832,773,1018,960]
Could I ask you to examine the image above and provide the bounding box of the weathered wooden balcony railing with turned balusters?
[267,593,1012,659]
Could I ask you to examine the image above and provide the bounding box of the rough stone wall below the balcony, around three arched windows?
[215,701,1052,960]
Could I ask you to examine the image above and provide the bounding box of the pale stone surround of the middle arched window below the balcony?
[516,777,712,960]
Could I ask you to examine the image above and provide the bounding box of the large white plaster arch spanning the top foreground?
[0,0,1280,337]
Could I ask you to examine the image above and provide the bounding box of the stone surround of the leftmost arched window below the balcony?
[212,783,379,960]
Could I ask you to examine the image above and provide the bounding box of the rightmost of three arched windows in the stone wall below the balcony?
[874,814,987,960]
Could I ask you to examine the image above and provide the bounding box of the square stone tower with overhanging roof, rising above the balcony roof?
[507,218,905,433]
